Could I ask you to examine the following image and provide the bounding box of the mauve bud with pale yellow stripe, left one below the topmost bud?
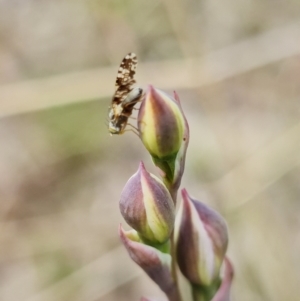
[120,163,175,244]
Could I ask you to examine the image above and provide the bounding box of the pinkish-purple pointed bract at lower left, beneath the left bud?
[119,226,179,301]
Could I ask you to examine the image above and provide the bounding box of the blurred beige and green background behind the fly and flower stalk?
[0,0,300,301]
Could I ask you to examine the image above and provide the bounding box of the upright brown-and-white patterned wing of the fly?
[112,52,137,105]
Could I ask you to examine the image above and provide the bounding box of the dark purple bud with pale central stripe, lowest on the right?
[175,189,228,286]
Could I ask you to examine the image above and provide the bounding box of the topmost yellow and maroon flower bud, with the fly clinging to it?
[138,86,188,188]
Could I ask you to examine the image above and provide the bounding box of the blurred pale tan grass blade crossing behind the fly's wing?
[0,23,300,117]
